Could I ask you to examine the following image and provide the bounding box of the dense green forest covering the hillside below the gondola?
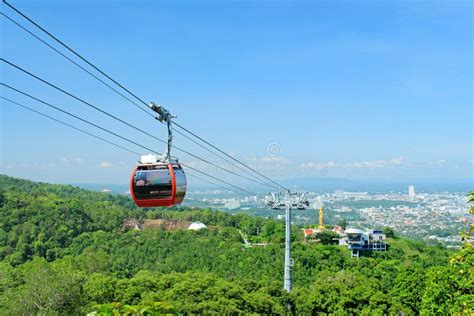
[0,176,474,315]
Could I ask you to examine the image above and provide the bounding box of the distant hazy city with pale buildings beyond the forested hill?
[185,185,474,247]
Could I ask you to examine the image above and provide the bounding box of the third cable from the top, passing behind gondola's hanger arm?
[0,58,269,186]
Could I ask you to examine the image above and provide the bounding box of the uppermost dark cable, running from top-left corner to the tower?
[3,0,289,191]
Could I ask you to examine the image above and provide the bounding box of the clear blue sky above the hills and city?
[0,0,474,183]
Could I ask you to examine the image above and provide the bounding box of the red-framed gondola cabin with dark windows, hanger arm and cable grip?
[130,102,186,207]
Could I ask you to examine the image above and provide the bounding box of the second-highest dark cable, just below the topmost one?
[0,12,278,189]
